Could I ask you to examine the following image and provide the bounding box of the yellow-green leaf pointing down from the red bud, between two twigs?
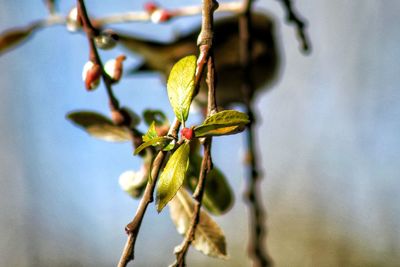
[156,142,190,212]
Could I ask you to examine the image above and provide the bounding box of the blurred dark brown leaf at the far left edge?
[0,23,40,55]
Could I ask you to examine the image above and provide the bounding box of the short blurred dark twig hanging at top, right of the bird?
[278,0,311,53]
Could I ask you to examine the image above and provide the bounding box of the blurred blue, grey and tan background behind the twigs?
[0,0,400,267]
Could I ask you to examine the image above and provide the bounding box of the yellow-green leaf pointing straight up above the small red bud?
[167,55,196,122]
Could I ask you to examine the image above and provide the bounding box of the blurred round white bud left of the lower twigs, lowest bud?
[118,170,147,198]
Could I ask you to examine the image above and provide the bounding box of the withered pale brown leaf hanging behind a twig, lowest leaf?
[169,189,227,259]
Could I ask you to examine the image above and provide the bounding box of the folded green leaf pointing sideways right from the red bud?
[194,110,250,137]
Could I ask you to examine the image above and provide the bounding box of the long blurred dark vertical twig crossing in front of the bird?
[239,0,272,267]
